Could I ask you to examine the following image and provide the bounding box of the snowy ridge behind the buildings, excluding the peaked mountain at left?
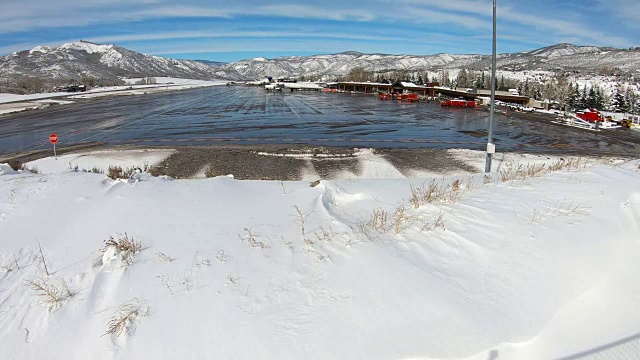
[221,44,640,78]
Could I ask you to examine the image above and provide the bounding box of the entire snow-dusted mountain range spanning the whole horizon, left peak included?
[0,41,640,85]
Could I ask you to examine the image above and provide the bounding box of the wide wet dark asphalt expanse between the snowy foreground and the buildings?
[0,86,640,156]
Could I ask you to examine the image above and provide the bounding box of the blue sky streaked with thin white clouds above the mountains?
[0,0,640,62]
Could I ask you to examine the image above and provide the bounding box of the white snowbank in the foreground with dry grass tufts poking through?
[0,150,640,360]
